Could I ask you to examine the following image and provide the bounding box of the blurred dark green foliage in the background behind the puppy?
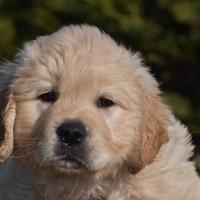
[0,0,200,132]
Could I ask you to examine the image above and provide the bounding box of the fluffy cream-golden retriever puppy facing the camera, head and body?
[0,25,200,200]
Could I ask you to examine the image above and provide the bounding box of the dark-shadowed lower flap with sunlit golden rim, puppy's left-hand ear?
[0,92,15,163]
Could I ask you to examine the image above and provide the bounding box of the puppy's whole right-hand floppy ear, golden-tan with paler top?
[129,66,171,172]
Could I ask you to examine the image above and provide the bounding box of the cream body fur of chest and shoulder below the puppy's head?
[0,121,200,200]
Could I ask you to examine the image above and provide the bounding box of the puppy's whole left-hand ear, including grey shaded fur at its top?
[0,59,21,163]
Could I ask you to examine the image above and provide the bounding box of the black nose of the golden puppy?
[56,121,86,146]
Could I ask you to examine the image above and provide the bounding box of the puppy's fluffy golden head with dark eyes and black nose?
[0,26,168,177]
